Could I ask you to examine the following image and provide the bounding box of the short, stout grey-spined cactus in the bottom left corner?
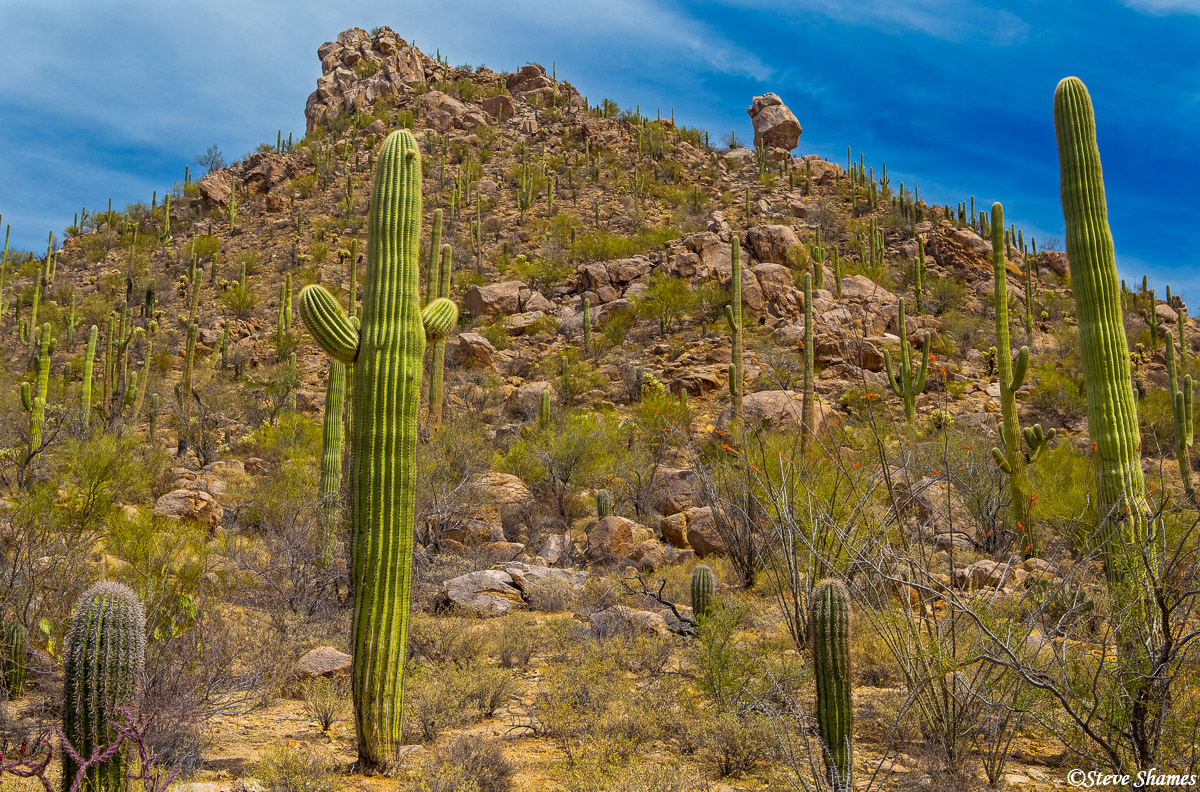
[62,581,146,792]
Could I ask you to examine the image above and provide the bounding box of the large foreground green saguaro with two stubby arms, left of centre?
[300,130,458,768]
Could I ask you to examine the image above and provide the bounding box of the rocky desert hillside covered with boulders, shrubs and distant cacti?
[0,21,1200,792]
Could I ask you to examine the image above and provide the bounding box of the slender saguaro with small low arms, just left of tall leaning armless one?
[991,202,1055,558]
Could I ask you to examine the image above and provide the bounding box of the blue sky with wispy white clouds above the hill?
[0,0,1200,300]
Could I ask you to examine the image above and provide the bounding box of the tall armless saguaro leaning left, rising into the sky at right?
[1054,77,1160,590]
